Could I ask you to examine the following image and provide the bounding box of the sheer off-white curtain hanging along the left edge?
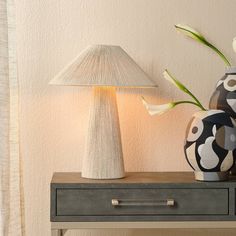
[0,0,24,236]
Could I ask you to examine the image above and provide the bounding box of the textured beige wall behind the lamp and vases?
[16,0,236,236]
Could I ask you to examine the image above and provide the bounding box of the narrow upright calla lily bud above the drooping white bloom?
[163,70,206,110]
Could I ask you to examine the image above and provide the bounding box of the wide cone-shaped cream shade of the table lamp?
[50,45,156,88]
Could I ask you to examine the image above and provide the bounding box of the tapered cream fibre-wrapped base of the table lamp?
[82,87,125,179]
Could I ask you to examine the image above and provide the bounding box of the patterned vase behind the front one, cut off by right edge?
[209,67,236,119]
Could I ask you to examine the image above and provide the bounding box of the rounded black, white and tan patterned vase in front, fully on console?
[184,110,236,181]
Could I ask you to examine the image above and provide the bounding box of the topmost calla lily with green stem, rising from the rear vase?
[175,24,230,66]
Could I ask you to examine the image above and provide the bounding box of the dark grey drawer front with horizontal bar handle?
[56,188,229,216]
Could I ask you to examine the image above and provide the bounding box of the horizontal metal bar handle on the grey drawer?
[111,199,175,206]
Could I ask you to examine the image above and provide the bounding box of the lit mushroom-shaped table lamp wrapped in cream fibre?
[50,45,156,179]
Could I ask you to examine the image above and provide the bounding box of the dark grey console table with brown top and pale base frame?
[51,172,236,236]
